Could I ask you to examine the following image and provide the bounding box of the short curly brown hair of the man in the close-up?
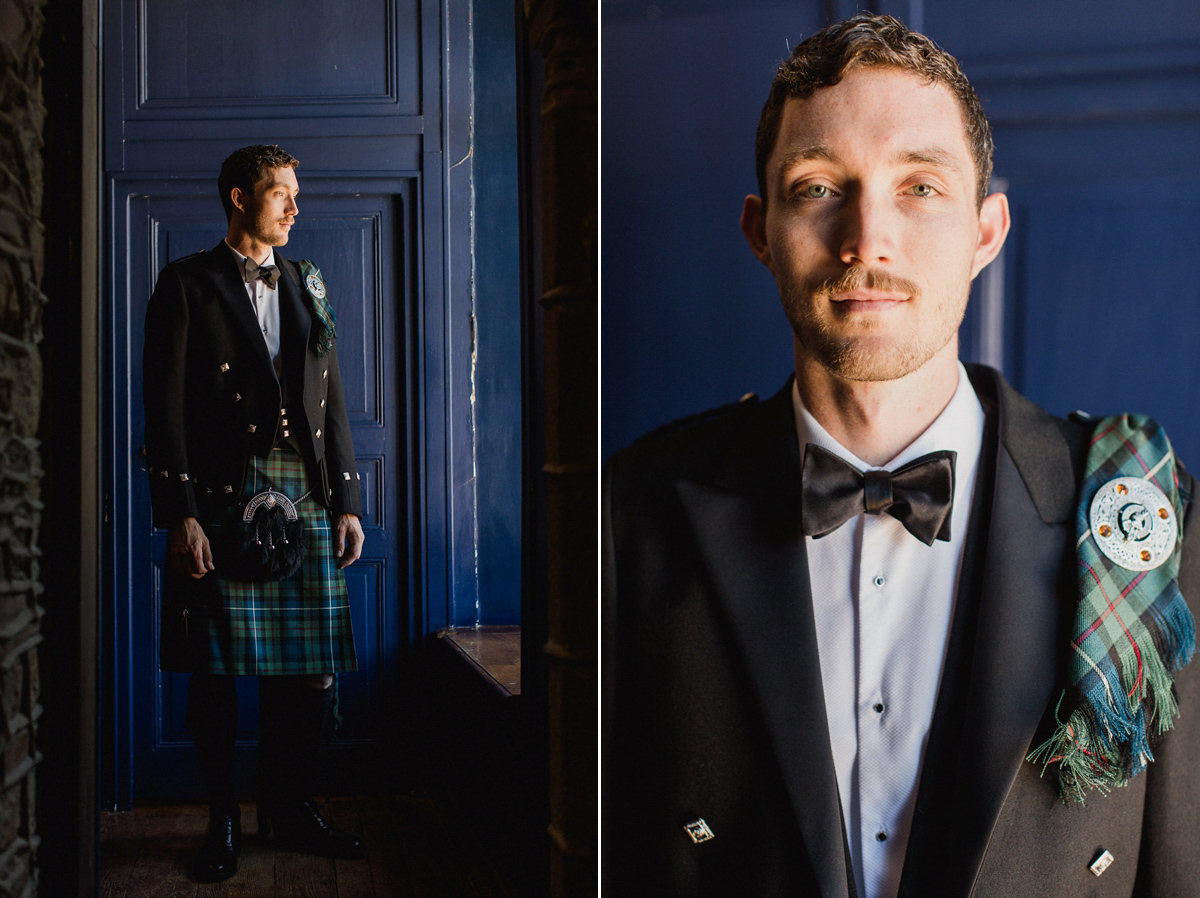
[755,14,994,205]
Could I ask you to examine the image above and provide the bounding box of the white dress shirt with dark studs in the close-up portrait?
[792,364,984,898]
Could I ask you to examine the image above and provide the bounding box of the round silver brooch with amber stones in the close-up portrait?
[1088,477,1176,570]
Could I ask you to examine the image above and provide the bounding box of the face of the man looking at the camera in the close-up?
[742,68,1008,381]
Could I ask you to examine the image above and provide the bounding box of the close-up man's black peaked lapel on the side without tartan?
[677,382,851,898]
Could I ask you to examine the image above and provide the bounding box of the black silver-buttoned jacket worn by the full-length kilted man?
[143,241,362,527]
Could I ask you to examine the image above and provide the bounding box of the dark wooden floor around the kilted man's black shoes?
[101,795,527,898]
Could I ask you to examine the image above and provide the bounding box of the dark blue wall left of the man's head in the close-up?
[600,4,820,457]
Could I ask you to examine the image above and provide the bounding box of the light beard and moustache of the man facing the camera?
[779,265,970,382]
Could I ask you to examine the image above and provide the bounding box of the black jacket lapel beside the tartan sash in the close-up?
[900,366,1080,897]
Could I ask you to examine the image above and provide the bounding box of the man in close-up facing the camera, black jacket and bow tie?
[602,16,1200,898]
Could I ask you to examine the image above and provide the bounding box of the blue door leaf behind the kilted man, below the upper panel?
[119,179,413,797]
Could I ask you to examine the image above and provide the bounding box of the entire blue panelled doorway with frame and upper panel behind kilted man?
[102,0,475,807]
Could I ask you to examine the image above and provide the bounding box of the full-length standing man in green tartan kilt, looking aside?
[143,146,364,882]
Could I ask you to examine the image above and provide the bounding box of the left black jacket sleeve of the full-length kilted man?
[142,265,199,527]
